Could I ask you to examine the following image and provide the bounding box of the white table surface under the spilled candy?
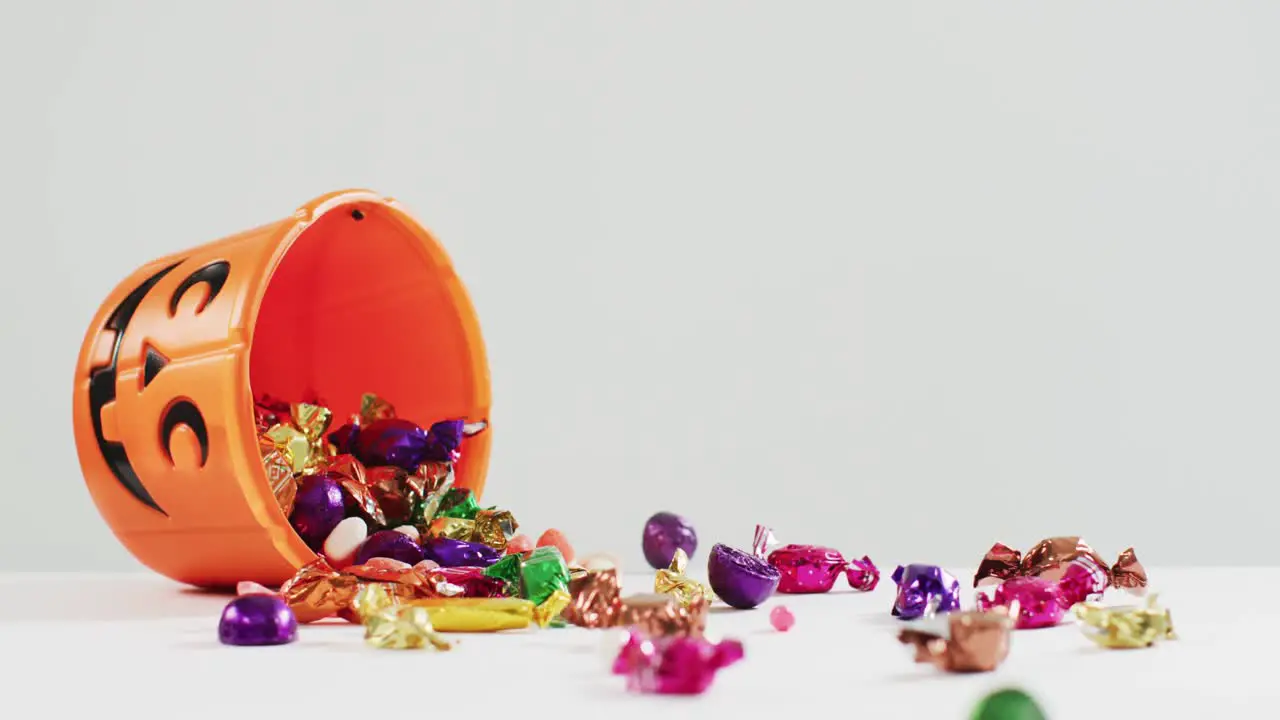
[0,568,1280,720]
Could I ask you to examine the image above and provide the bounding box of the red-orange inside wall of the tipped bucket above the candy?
[250,202,486,443]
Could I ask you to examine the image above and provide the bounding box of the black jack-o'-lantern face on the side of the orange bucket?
[88,260,230,515]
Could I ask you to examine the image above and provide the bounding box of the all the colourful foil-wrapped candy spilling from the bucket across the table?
[219,395,1176,702]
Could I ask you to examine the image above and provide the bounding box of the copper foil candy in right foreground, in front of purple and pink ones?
[897,610,1014,673]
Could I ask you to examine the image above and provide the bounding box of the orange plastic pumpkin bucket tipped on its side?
[73,190,493,588]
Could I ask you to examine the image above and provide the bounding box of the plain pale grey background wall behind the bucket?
[0,0,1280,570]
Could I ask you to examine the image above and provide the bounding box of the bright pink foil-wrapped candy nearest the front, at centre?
[613,630,744,694]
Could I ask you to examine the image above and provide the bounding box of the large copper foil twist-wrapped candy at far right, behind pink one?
[973,536,1147,606]
